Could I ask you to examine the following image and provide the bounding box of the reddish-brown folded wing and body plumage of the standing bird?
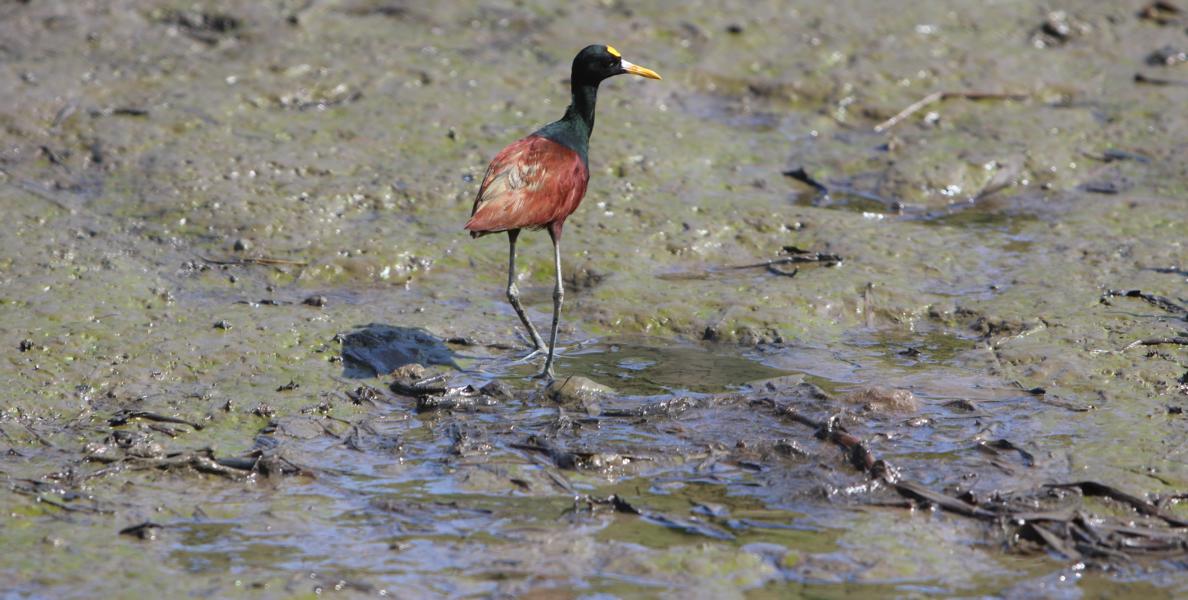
[466,135,589,236]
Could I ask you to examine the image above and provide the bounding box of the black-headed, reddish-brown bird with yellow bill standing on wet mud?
[465,44,661,380]
